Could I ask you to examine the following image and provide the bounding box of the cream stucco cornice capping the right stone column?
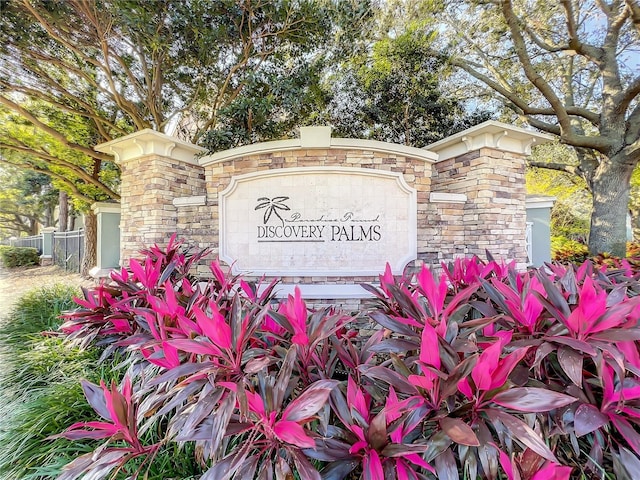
[425,120,554,160]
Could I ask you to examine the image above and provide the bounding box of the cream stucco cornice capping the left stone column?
[94,128,207,165]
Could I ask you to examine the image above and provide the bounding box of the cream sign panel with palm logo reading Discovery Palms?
[219,167,416,276]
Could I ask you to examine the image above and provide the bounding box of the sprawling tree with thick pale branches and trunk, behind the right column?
[434,0,640,255]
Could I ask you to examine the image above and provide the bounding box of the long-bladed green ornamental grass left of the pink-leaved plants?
[0,285,95,479]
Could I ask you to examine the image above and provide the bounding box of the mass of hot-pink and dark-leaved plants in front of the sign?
[47,237,640,480]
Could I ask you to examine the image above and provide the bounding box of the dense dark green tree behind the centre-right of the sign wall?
[324,1,492,147]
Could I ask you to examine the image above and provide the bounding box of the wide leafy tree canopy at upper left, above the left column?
[0,0,369,270]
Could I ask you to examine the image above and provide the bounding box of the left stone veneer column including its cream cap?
[95,129,206,263]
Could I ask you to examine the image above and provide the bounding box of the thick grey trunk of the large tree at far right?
[589,157,633,257]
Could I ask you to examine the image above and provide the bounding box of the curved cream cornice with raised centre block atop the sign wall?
[199,127,438,167]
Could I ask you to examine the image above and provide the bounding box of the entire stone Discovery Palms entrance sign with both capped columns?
[96,121,550,300]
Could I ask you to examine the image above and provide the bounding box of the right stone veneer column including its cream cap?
[425,121,552,267]
